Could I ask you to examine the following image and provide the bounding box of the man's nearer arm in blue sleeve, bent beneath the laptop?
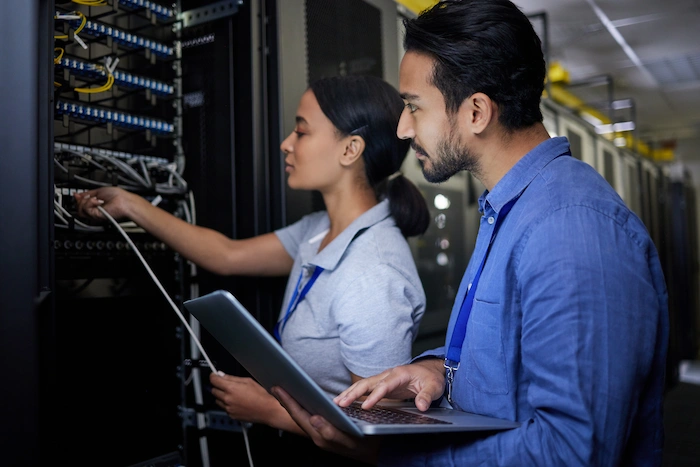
[372,211,665,466]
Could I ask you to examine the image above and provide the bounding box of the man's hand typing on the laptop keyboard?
[333,358,445,412]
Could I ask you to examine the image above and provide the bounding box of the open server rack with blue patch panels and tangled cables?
[50,0,192,465]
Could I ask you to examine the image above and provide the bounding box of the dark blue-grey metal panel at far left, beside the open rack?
[0,0,53,465]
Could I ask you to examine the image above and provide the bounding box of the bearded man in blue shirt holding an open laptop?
[273,0,668,467]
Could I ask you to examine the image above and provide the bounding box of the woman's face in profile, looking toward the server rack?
[280,90,345,192]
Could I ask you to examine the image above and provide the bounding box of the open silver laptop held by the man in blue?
[184,290,520,436]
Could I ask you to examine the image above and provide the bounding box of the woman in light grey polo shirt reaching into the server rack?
[76,76,429,458]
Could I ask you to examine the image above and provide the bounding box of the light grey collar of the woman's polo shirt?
[303,199,391,271]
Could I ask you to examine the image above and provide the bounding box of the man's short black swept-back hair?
[403,0,546,130]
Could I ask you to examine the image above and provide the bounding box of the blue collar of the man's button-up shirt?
[479,136,569,213]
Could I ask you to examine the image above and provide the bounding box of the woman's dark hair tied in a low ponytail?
[309,75,430,237]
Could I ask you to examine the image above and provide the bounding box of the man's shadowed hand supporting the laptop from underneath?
[270,387,379,464]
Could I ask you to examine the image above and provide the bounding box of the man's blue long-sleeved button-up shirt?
[382,137,668,467]
